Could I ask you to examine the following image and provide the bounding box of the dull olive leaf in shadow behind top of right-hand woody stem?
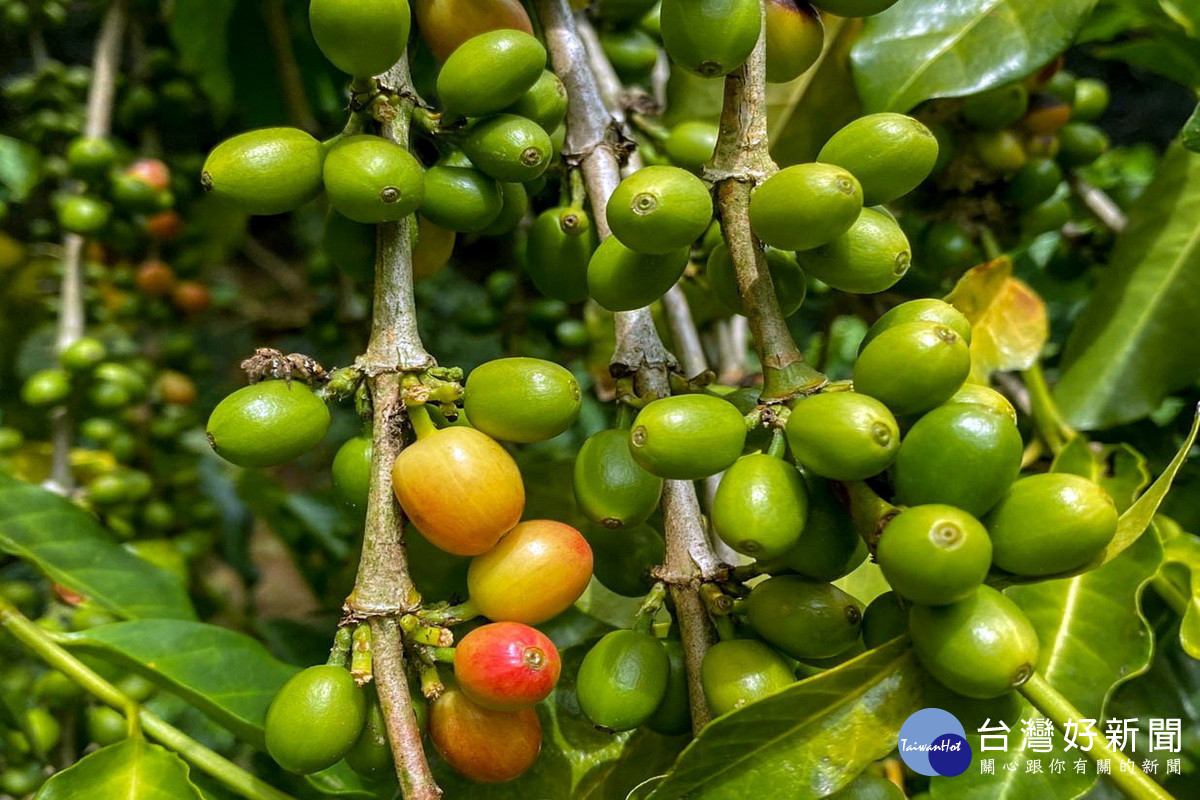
[767,19,863,167]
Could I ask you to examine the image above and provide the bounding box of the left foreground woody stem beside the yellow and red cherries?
[346,54,442,800]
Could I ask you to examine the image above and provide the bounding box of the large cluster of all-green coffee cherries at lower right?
[575,293,1117,732]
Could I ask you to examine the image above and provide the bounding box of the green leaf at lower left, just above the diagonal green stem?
[68,620,298,746]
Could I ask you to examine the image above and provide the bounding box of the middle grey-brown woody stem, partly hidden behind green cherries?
[536,0,719,730]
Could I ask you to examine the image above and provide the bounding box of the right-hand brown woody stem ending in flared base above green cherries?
[704,7,826,403]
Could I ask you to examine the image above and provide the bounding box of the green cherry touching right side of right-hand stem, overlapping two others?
[750,163,863,249]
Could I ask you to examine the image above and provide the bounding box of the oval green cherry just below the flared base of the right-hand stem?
[786,392,900,481]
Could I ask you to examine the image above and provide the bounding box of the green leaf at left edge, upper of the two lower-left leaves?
[0,475,196,619]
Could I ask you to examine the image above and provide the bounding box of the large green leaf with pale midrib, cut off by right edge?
[1055,145,1200,431]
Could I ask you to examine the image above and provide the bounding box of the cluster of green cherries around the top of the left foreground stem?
[202,0,566,271]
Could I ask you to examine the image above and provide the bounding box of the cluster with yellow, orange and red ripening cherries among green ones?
[208,350,593,782]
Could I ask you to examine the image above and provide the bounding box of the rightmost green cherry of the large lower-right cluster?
[985,473,1117,576]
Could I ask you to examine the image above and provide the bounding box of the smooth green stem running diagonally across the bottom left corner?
[0,597,294,800]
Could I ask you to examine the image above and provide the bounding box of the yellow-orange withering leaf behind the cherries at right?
[946,258,1050,381]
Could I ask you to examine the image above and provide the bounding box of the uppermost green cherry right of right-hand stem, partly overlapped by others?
[817,113,937,205]
